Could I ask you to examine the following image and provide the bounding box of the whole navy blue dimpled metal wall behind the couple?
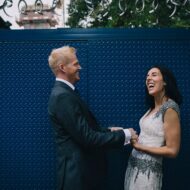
[0,29,190,190]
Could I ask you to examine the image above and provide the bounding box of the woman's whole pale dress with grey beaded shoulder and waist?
[124,99,179,190]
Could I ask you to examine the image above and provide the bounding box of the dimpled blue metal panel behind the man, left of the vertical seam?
[0,41,87,190]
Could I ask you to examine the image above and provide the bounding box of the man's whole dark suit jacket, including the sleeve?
[48,81,125,190]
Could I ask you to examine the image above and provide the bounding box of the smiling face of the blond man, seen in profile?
[64,54,81,84]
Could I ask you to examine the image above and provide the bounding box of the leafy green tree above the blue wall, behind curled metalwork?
[67,0,190,28]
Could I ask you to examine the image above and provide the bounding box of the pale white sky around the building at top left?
[0,0,70,29]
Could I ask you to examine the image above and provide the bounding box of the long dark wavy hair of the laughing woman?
[145,65,182,109]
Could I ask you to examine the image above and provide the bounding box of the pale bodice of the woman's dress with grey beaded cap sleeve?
[132,99,179,163]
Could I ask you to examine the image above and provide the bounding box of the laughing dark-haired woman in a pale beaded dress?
[125,66,182,190]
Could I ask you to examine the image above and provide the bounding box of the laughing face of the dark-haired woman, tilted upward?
[146,68,165,97]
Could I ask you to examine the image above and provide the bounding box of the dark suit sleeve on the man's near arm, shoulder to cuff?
[56,95,125,148]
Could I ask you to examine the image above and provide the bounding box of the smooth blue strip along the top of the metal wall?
[0,28,190,41]
